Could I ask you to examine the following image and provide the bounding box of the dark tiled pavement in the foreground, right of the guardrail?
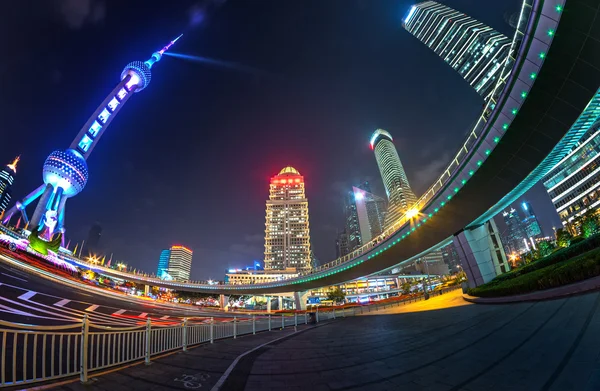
[48,292,600,391]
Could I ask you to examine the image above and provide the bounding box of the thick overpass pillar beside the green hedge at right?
[453,219,510,288]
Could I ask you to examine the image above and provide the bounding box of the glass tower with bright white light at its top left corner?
[352,187,386,243]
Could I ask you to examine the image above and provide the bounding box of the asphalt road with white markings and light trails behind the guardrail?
[0,254,238,326]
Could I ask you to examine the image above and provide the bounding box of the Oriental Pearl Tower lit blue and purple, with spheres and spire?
[2,34,183,245]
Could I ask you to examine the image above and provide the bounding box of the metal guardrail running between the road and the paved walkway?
[0,286,460,388]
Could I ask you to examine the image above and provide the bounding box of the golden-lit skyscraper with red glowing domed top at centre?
[265,166,311,271]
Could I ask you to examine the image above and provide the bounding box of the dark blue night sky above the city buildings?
[0,0,560,279]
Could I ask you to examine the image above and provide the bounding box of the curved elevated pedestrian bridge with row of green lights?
[71,0,600,294]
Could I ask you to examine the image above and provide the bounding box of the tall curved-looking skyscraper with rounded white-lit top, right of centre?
[371,129,417,229]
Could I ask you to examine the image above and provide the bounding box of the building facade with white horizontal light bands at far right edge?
[542,121,600,234]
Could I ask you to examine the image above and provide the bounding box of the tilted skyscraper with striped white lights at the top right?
[403,1,511,100]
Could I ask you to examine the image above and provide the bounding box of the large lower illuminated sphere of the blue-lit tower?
[42,149,88,197]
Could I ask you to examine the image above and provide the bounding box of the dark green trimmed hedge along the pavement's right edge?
[469,249,600,297]
